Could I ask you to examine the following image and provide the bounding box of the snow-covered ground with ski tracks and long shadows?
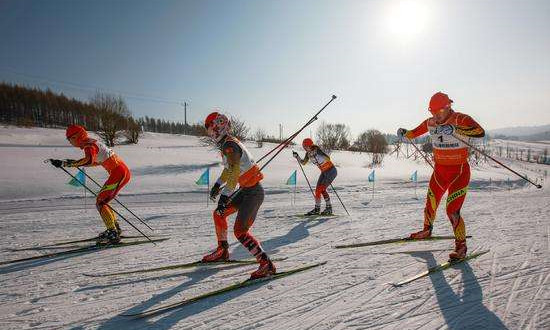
[0,127,550,329]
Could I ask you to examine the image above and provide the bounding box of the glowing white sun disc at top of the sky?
[387,0,430,41]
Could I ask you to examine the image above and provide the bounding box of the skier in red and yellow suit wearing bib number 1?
[397,92,485,260]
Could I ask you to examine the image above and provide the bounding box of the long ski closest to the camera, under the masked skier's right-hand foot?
[122,261,327,318]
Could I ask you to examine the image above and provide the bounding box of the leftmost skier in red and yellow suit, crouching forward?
[51,125,131,244]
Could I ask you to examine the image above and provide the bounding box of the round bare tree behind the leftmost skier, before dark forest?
[90,92,131,147]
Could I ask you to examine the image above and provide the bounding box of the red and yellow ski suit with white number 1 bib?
[405,110,485,241]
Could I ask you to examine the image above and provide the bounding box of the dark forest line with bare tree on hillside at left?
[0,82,206,146]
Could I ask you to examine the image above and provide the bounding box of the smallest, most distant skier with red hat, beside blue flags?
[292,138,338,215]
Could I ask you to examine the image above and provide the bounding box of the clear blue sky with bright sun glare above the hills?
[0,0,550,137]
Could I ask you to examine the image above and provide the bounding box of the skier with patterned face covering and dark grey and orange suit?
[202,112,276,279]
